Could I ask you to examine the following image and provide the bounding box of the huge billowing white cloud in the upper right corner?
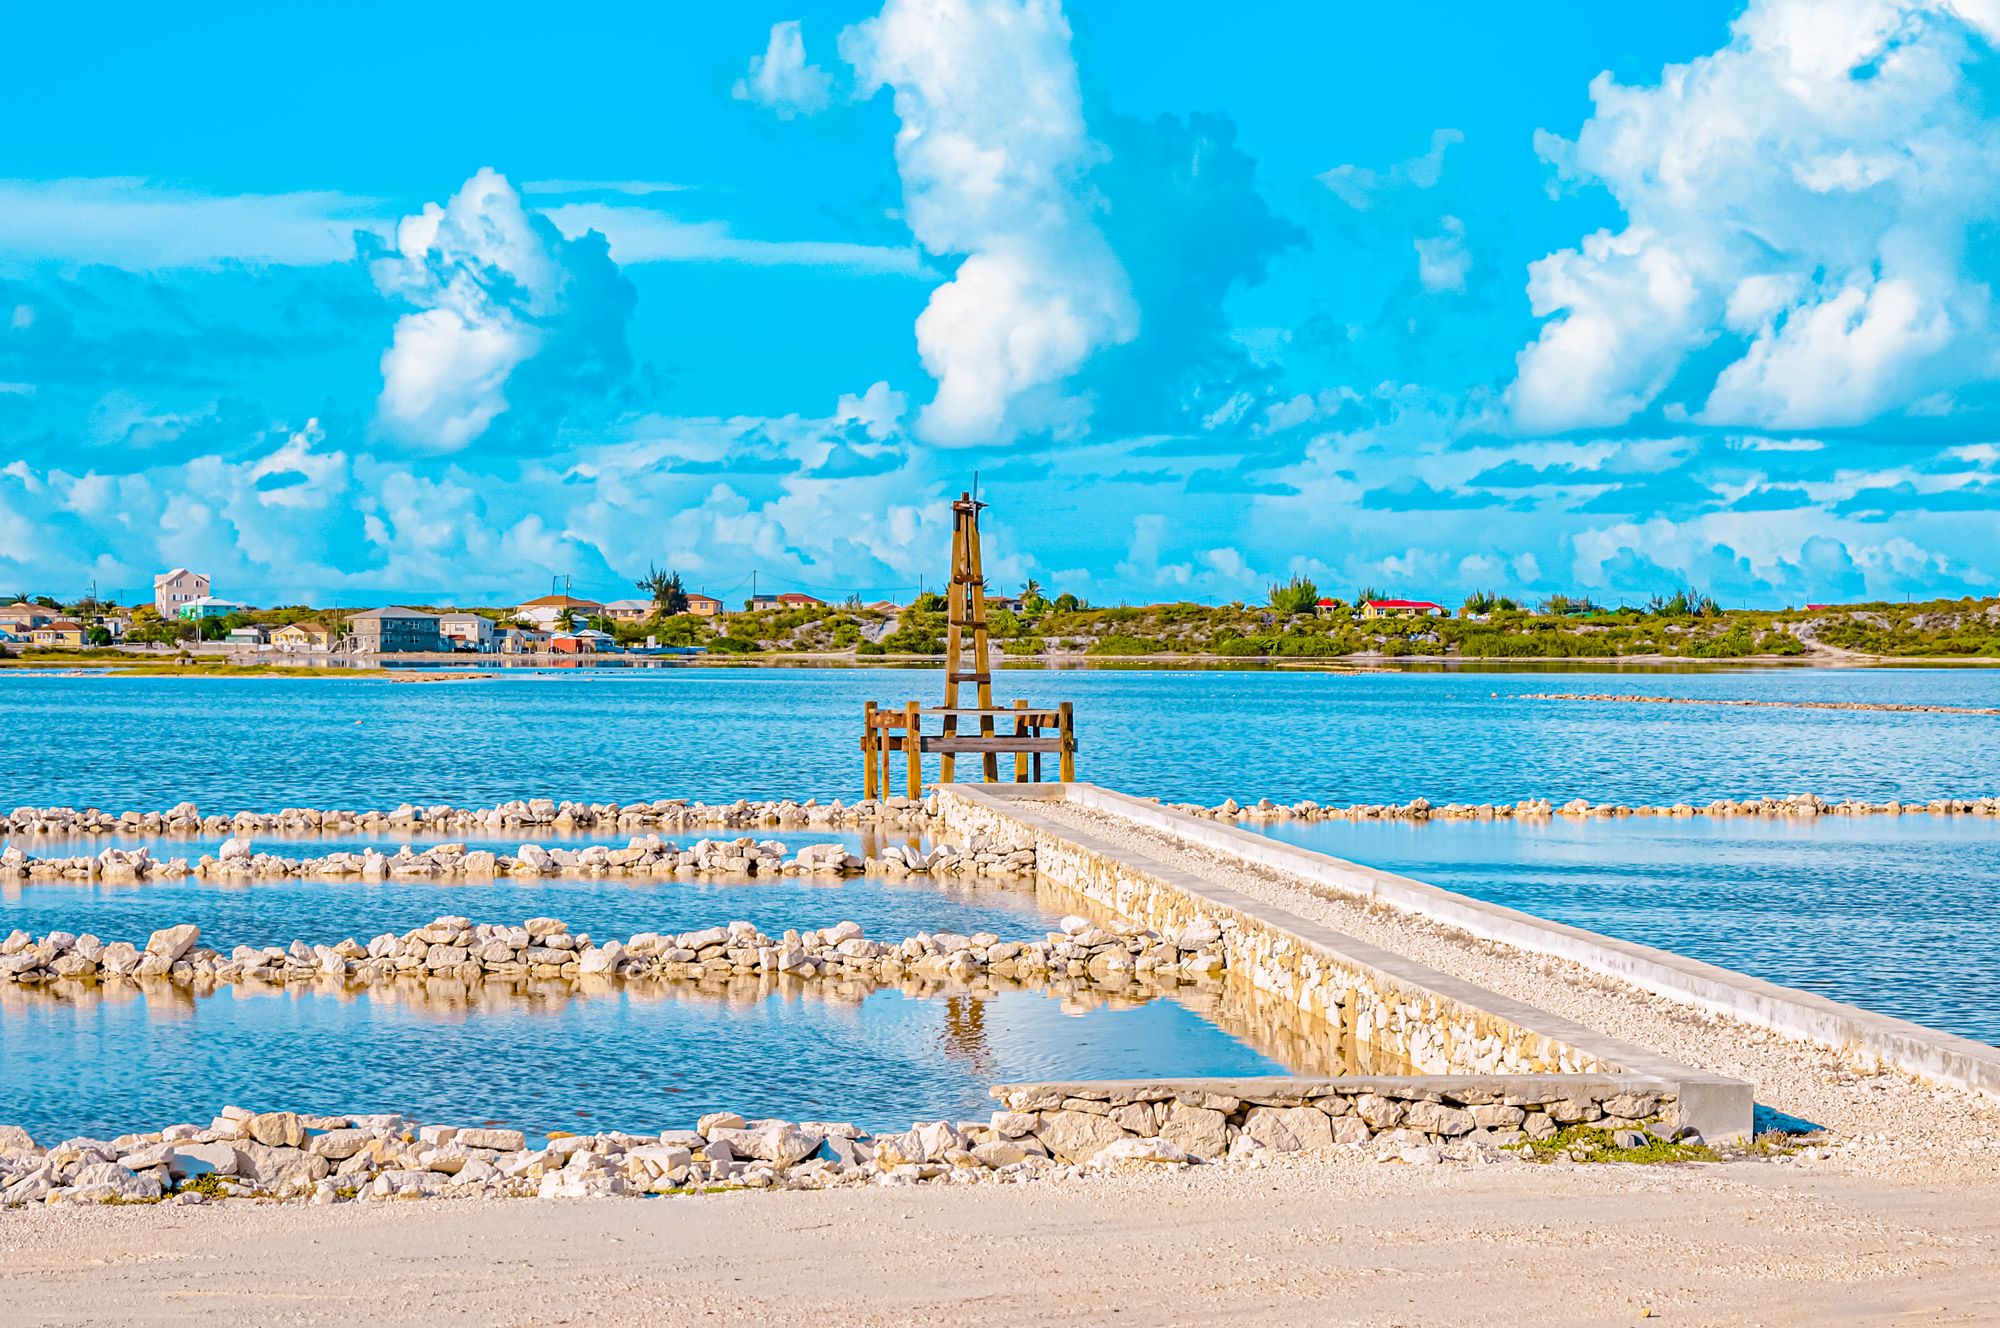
[1508,0,2000,430]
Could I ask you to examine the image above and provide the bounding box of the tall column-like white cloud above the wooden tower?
[840,0,1138,446]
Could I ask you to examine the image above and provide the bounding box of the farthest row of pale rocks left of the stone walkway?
[0,798,928,834]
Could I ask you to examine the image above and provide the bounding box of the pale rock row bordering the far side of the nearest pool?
[0,918,1228,984]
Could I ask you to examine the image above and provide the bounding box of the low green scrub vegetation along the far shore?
[0,584,2000,670]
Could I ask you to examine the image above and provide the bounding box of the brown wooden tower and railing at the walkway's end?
[862,492,1076,802]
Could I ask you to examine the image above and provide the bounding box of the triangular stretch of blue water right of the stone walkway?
[1244,816,2000,1042]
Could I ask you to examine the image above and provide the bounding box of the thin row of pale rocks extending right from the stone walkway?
[1170,794,2000,822]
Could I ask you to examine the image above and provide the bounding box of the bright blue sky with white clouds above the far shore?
[0,0,2000,604]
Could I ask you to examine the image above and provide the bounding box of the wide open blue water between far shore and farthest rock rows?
[0,668,2000,810]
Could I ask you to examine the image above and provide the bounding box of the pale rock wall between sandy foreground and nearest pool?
[0,1080,1686,1208]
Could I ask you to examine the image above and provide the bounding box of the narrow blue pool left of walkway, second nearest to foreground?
[0,876,1062,952]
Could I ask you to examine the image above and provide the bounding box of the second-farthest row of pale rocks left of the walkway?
[0,834,1034,882]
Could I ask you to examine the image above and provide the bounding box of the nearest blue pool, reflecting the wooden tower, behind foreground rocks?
[0,984,1284,1142]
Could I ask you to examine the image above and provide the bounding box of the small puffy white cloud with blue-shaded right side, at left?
[374,168,636,452]
